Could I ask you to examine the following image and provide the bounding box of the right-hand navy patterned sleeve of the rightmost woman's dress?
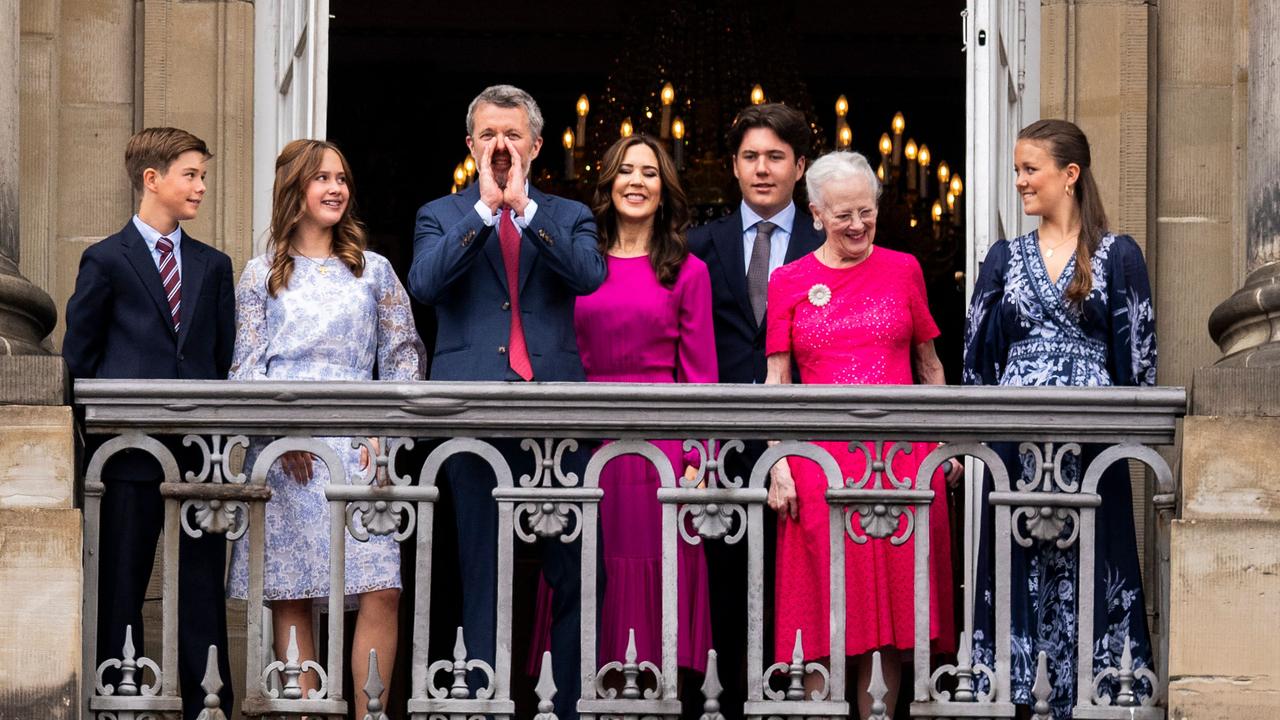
[1107,236,1156,386]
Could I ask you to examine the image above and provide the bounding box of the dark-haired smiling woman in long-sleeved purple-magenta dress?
[552,135,717,673]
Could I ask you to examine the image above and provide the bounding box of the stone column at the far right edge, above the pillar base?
[1208,3,1280,368]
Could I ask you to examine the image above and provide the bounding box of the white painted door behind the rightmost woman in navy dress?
[964,0,1039,299]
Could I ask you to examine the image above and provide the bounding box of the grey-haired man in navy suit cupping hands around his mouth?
[408,85,605,720]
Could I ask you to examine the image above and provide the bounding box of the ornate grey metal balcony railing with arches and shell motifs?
[76,380,1187,720]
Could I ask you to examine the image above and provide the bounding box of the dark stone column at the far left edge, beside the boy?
[0,0,58,356]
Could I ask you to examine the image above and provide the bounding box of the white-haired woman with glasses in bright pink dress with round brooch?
[765,152,960,717]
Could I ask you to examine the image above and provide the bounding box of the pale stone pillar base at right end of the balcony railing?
[1169,366,1280,720]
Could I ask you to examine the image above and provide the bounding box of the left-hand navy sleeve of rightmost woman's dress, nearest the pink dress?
[960,240,1009,386]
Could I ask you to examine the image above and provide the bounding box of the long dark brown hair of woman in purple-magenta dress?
[591,135,689,287]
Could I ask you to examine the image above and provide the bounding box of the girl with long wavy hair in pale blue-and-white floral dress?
[228,140,425,717]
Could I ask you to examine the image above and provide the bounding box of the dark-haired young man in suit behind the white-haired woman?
[689,102,823,717]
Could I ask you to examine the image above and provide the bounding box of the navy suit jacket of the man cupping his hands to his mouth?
[408,186,605,382]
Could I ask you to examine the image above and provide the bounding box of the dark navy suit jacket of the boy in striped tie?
[63,219,236,480]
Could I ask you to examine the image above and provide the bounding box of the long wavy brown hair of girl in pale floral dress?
[266,140,365,297]
